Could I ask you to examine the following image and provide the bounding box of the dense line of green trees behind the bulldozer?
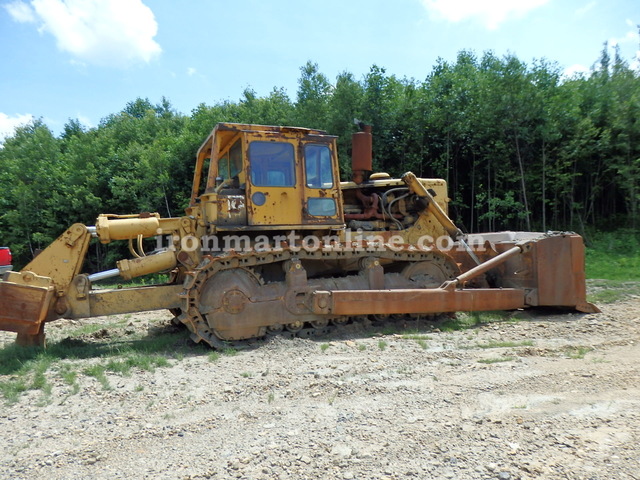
[0,45,640,269]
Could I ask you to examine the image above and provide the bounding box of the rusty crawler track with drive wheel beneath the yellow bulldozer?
[178,244,457,349]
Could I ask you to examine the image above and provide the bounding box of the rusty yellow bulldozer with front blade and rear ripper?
[0,123,598,349]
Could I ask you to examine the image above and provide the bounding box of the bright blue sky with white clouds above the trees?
[0,0,640,141]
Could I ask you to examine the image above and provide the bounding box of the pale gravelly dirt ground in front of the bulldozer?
[0,298,640,480]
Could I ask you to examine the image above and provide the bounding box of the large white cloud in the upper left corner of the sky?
[5,0,162,67]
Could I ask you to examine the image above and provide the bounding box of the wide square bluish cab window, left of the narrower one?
[249,141,296,187]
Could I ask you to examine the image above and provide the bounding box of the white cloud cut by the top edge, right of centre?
[422,0,549,30]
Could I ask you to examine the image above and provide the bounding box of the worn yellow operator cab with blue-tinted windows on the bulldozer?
[190,123,344,231]
